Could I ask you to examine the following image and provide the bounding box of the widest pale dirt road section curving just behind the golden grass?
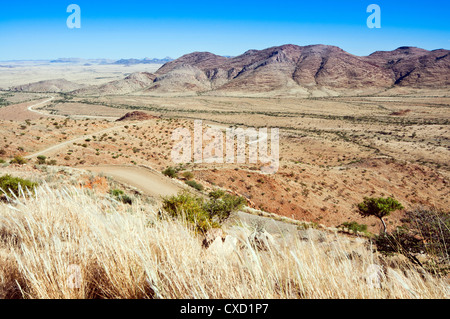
[82,165,184,198]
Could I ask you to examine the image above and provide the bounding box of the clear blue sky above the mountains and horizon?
[0,0,450,61]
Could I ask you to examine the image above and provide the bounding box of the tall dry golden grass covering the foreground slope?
[0,185,449,298]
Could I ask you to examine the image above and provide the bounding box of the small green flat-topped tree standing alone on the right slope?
[358,197,403,233]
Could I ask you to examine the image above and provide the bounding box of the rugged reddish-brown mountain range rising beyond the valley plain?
[8,44,450,95]
